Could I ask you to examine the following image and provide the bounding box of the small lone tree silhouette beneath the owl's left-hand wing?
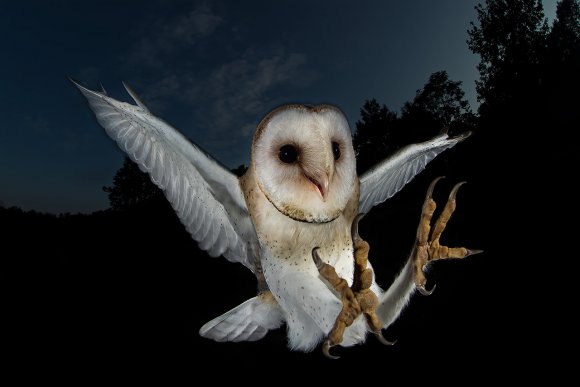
[103,157,163,211]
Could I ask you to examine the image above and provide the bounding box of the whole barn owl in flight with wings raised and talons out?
[71,80,479,357]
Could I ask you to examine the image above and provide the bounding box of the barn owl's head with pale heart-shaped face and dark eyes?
[252,105,358,223]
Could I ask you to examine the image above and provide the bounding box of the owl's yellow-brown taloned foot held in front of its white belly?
[312,214,394,359]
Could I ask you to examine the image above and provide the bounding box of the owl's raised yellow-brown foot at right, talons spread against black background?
[411,177,483,296]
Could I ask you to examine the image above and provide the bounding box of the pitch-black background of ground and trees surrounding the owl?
[0,1,580,383]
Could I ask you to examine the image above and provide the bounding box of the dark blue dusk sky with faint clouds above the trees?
[0,0,556,213]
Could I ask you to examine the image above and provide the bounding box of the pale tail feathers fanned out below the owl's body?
[199,291,284,342]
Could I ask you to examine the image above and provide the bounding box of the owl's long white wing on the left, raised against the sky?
[71,79,258,273]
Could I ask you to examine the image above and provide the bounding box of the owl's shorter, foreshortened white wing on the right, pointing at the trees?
[359,132,471,213]
